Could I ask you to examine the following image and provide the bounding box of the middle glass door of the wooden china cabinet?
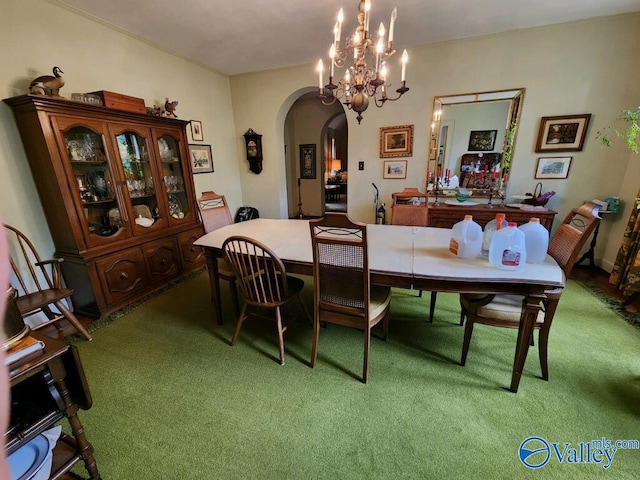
[115,129,167,233]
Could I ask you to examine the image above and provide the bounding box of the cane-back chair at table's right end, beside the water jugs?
[460,202,600,380]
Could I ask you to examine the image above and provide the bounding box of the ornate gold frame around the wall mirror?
[427,88,525,196]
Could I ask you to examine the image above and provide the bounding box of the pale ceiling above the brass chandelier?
[54,0,640,75]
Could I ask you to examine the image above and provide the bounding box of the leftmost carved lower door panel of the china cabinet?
[96,248,147,304]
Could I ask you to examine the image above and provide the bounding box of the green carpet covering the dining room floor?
[74,273,640,480]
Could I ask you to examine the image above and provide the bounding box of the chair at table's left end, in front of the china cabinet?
[197,191,240,324]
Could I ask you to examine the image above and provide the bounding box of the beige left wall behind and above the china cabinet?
[0,0,242,255]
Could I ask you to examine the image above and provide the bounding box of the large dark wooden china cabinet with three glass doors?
[4,95,204,318]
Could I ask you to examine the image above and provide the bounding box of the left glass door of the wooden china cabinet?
[54,118,130,245]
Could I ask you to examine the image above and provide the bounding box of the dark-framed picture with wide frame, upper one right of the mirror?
[536,113,591,153]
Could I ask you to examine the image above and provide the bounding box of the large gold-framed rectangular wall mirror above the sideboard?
[427,88,525,196]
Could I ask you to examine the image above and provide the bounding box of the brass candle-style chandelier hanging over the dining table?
[317,0,409,123]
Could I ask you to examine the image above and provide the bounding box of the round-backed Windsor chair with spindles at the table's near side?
[222,236,311,365]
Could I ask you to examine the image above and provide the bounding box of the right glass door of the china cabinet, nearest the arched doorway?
[158,134,193,223]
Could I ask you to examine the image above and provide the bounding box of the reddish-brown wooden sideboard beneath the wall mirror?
[427,203,558,231]
